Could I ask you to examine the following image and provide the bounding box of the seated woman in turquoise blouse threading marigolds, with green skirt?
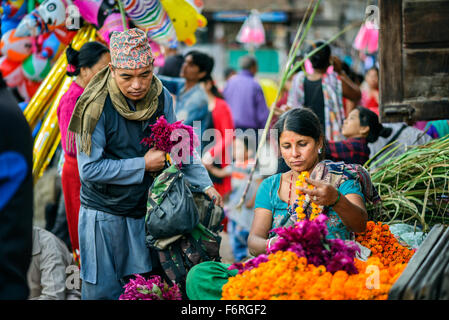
[186,108,380,299]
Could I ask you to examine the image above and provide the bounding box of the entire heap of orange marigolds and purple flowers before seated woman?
[222,215,413,300]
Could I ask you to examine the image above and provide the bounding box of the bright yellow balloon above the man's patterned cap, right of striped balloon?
[161,0,207,46]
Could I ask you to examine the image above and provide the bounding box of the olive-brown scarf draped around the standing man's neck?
[67,66,162,156]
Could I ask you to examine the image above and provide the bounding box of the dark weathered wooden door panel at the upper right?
[379,0,449,122]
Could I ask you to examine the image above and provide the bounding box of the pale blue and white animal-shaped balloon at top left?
[16,0,67,37]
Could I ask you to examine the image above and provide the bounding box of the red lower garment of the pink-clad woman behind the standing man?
[61,154,81,252]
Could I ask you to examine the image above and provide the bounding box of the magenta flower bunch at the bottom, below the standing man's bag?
[119,274,182,300]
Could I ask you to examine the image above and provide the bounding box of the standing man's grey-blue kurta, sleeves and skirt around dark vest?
[77,88,212,299]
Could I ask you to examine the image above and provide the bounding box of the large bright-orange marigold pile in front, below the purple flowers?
[222,251,406,300]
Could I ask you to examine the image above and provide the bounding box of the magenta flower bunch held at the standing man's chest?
[141,116,199,165]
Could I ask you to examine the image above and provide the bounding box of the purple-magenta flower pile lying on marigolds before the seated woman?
[229,214,360,274]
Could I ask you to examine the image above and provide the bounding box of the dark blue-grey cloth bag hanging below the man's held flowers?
[145,165,199,241]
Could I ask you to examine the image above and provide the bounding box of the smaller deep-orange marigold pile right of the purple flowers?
[356,221,414,266]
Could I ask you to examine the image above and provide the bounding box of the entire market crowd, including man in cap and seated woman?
[0,29,449,300]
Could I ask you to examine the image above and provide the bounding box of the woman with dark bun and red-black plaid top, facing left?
[325,107,391,165]
